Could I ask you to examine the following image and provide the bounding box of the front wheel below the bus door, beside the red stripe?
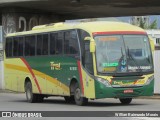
[74,83,88,106]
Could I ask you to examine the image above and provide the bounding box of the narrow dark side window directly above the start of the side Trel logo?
[50,33,57,55]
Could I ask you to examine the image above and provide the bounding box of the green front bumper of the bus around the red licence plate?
[95,80,154,99]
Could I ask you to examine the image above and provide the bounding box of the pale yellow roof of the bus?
[7,21,145,37]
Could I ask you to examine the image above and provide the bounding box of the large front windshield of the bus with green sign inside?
[95,35,153,74]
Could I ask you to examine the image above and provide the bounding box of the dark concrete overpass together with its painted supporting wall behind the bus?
[0,0,160,33]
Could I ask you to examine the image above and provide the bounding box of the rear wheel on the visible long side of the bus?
[25,82,37,103]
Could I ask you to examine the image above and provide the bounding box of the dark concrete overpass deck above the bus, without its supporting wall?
[0,0,160,18]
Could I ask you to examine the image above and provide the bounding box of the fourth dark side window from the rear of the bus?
[25,36,36,56]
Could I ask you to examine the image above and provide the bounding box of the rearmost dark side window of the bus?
[5,38,13,57]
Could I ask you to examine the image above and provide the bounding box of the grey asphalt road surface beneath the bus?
[0,93,160,120]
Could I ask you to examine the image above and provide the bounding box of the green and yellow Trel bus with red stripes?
[4,21,154,105]
